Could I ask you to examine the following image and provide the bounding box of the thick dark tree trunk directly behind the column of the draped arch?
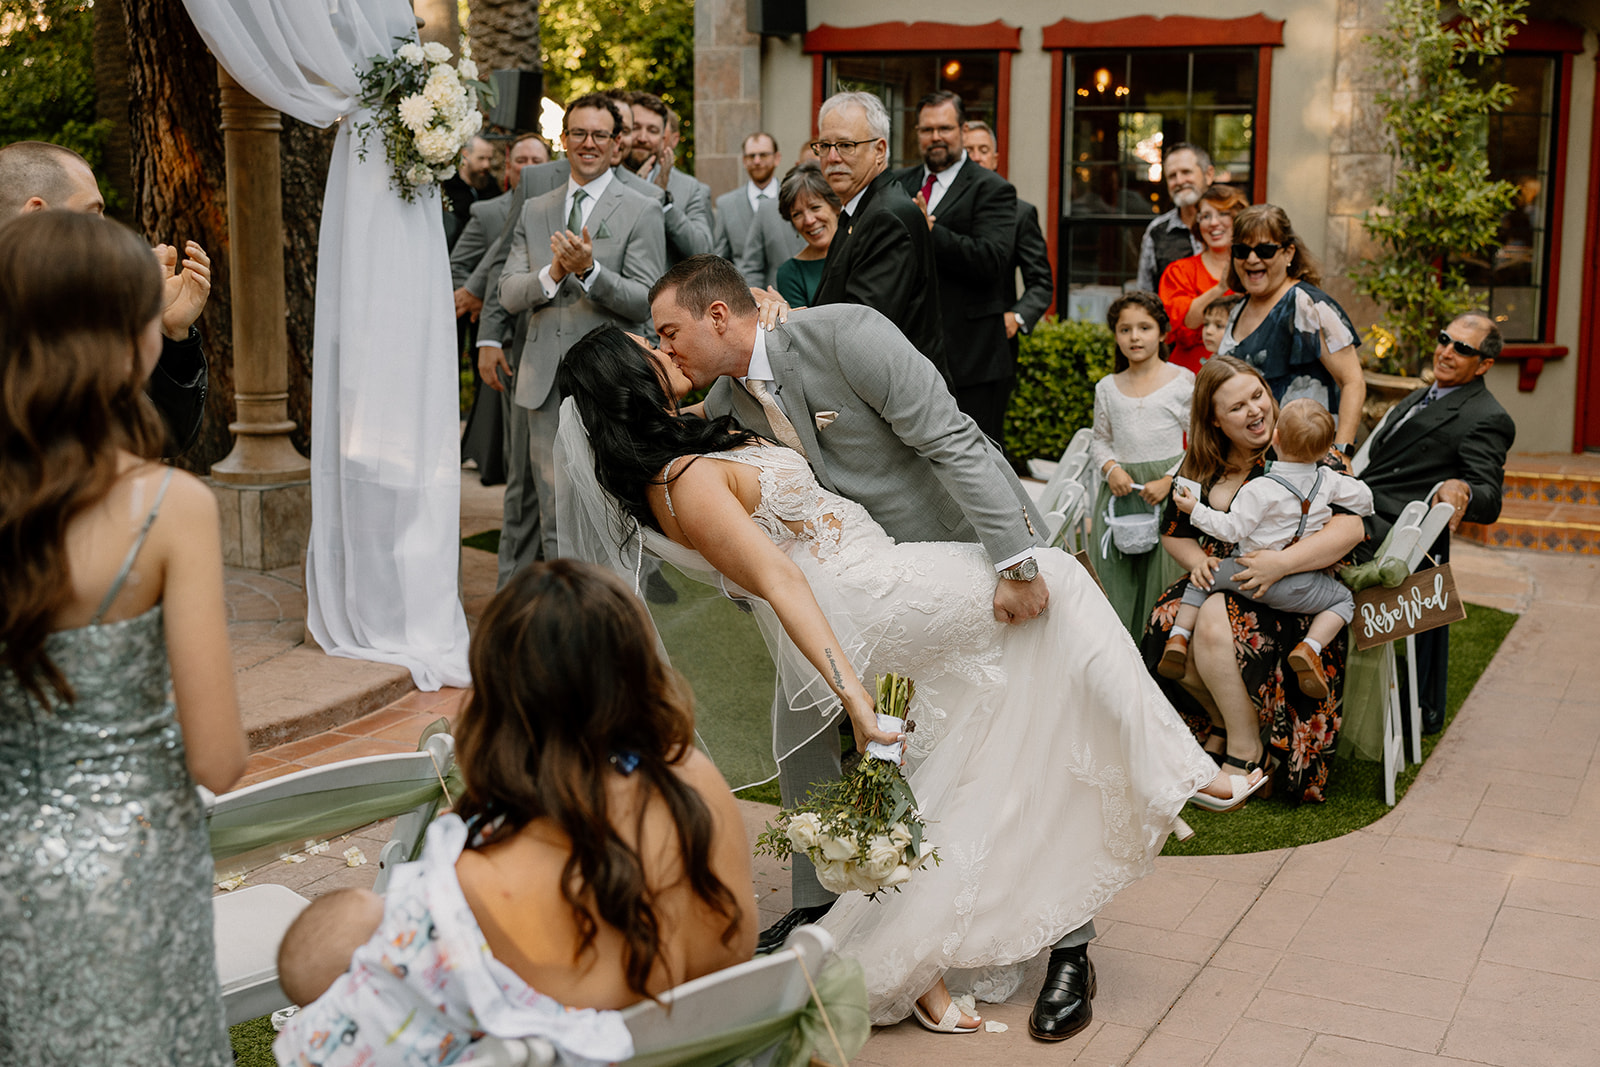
[123,0,333,472]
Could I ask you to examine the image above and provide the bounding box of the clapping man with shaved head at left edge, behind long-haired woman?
[0,141,211,456]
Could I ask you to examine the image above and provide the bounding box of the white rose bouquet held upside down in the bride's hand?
[755,675,939,899]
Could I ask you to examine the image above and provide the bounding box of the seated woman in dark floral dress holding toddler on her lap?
[1141,355,1365,801]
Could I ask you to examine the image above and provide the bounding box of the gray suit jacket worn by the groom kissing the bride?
[706,304,1045,561]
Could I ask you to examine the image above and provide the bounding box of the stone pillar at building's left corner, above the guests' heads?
[694,0,761,197]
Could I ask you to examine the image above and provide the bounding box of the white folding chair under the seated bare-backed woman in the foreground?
[472,926,834,1067]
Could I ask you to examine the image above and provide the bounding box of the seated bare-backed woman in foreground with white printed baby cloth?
[275,560,755,1062]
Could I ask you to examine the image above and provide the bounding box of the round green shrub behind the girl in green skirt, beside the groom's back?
[1005,315,1114,464]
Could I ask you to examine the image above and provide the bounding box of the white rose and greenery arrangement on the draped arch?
[355,38,494,203]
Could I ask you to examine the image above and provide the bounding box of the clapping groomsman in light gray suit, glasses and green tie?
[480,93,666,560]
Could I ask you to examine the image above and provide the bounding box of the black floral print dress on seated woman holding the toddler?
[1139,461,1347,803]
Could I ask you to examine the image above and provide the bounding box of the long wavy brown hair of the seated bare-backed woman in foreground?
[456,560,747,997]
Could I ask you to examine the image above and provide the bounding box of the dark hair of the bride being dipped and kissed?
[555,325,757,530]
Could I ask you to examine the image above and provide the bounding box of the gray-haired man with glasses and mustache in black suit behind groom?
[811,93,950,382]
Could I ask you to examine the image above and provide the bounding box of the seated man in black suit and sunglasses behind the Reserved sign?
[1360,312,1517,733]
